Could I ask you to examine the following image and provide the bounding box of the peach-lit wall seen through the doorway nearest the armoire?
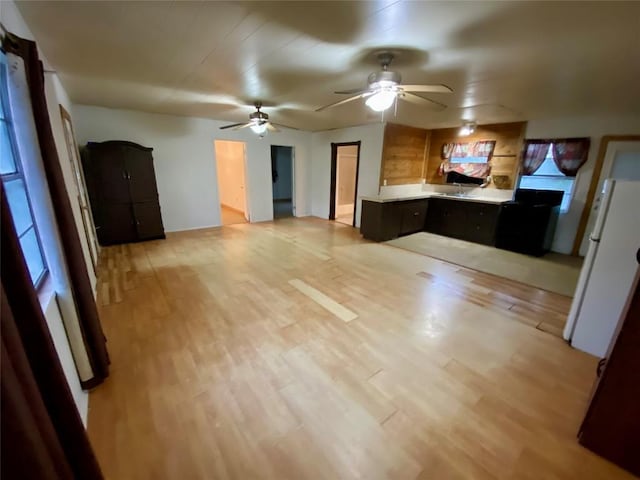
[215,140,246,213]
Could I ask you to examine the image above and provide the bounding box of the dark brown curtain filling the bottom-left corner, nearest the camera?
[0,182,102,480]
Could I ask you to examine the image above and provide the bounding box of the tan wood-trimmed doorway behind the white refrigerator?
[574,136,640,256]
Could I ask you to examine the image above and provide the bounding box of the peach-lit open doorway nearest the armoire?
[214,140,249,225]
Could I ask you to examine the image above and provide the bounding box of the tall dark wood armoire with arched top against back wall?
[82,140,165,245]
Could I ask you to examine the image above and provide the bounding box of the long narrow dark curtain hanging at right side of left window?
[3,35,109,388]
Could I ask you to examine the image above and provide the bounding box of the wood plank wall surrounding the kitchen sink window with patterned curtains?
[424,122,527,188]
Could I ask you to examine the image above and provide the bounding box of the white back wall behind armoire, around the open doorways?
[73,105,311,231]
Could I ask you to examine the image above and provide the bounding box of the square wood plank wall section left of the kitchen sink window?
[380,123,429,185]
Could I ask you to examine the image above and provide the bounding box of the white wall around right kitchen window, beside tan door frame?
[525,115,640,254]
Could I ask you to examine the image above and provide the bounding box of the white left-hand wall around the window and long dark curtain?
[0,0,90,424]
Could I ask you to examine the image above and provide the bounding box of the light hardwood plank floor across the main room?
[88,218,632,480]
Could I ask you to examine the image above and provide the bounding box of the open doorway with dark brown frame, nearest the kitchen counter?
[329,142,360,227]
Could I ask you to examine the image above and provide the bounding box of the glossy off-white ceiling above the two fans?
[17,0,640,130]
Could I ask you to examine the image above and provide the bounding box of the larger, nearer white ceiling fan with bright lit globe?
[316,52,453,112]
